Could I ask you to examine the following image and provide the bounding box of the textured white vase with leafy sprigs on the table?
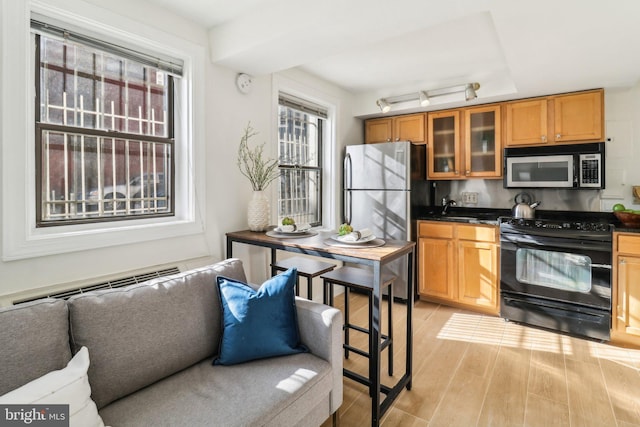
[237,122,280,231]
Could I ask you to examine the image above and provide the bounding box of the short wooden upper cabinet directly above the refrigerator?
[364,113,426,144]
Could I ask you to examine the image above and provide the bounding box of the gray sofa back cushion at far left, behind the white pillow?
[0,299,71,395]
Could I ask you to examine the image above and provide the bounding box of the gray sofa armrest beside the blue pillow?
[296,297,344,413]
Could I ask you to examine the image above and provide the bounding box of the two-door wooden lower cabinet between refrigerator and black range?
[418,221,500,314]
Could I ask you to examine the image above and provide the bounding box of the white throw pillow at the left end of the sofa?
[0,347,104,427]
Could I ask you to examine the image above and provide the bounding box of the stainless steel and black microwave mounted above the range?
[503,142,605,189]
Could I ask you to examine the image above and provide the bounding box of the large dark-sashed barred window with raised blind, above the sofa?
[31,19,182,227]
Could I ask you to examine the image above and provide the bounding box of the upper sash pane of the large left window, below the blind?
[40,36,169,137]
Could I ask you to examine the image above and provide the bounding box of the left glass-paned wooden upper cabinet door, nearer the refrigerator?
[427,110,462,179]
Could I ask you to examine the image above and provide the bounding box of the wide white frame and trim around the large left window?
[0,0,206,261]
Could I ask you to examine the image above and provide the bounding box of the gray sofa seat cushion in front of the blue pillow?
[100,353,333,427]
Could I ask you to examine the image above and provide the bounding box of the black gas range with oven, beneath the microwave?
[498,212,615,340]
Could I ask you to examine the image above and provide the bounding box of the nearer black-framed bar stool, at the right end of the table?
[320,266,396,385]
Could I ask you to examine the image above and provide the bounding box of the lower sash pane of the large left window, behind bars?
[41,131,171,221]
